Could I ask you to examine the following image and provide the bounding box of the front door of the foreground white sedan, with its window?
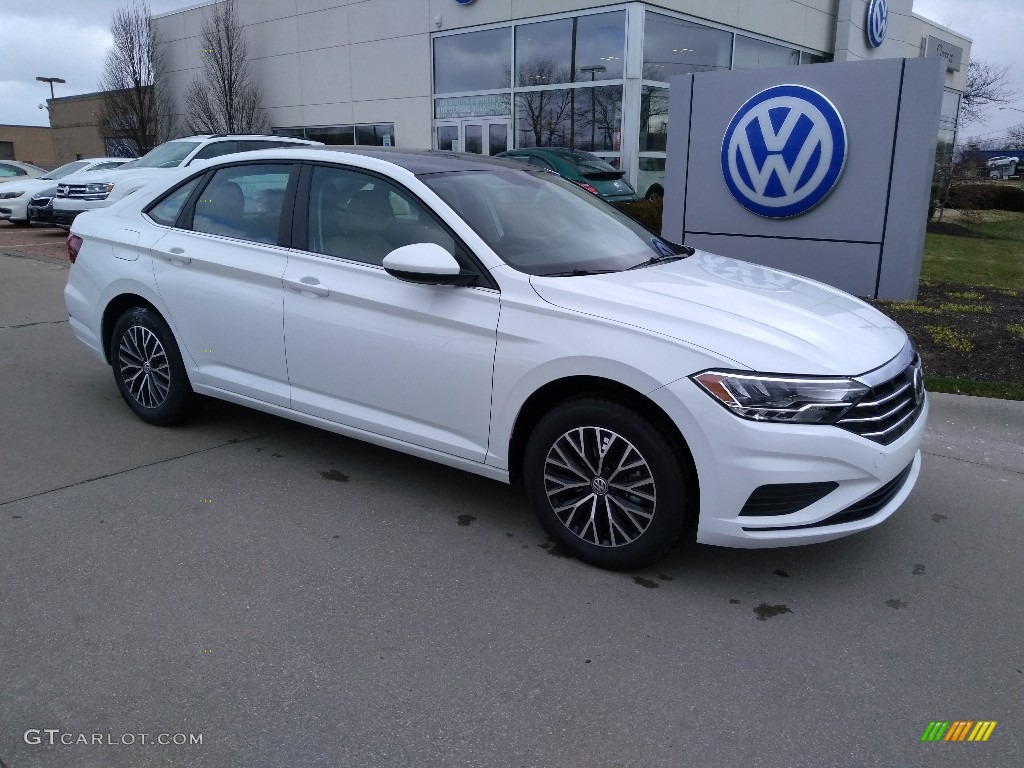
[285,166,499,462]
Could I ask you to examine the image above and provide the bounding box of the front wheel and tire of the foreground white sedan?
[523,398,696,570]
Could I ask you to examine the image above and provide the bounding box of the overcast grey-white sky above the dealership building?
[0,0,1024,143]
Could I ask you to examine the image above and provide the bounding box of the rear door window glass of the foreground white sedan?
[193,164,292,243]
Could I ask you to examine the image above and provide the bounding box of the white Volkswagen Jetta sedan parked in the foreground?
[66,147,928,568]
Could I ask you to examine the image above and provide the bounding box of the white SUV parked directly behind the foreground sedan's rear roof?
[53,134,321,226]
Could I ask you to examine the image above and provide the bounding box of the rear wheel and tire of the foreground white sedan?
[111,307,198,426]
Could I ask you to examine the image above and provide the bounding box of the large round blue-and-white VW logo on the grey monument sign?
[722,85,847,218]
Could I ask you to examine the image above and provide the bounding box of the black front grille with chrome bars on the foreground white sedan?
[836,354,925,445]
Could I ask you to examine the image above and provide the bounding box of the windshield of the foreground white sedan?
[421,169,680,275]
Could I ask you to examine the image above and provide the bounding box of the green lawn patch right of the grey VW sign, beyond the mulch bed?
[921,214,1024,291]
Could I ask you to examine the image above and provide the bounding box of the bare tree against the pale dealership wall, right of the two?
[185,0,268,133]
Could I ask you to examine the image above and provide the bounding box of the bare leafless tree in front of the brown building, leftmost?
[99,0,171,157]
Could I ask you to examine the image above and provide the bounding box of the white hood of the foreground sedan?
[530,251,907,376]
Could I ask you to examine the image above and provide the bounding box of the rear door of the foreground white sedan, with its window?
[150,161,298,406]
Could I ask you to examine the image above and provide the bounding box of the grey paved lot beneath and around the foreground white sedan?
[0,228,1024,768]
